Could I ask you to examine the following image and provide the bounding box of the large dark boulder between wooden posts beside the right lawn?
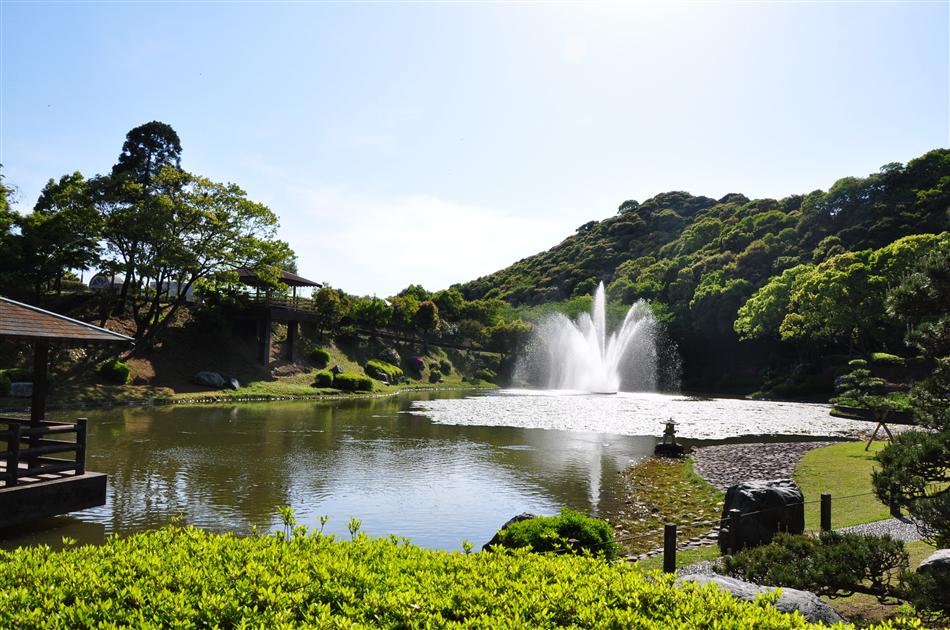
[719,479,805,554]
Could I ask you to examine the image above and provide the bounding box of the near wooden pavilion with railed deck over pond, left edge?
[0,297,133,527]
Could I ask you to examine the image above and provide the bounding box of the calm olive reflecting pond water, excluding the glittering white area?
[0,392,655,549]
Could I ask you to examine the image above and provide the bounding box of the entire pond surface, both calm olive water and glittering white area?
[0,390,863,549]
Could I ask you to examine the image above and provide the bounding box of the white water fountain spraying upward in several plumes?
[517,282,658,394]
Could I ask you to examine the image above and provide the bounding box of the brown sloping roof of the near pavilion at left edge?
[0,296,135,343]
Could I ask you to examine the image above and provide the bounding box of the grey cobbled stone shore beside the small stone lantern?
[690,442,834,490]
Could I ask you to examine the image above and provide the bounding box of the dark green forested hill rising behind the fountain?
[460,149,950,396]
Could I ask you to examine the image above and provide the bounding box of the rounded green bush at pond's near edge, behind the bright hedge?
[498,507,619,560]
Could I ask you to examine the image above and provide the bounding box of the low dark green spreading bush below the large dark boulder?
[719,532,909,598]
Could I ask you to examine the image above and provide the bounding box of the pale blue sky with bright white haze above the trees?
[0,0,950,296]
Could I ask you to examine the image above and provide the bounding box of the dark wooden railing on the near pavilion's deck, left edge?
[0,418,86,487]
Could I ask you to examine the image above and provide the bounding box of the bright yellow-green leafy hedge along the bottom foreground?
[0,527,890,630]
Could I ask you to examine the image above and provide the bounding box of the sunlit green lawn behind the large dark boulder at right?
[794,442,890,531]
